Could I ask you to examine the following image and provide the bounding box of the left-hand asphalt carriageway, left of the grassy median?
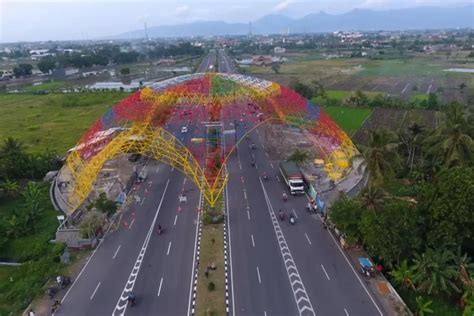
[56,123,200,316]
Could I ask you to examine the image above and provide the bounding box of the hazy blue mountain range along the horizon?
[112,5,474,39]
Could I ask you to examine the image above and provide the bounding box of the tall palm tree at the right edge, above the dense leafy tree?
[426,102,474,168]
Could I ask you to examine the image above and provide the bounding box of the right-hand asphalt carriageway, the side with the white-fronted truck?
[224,107,382,316]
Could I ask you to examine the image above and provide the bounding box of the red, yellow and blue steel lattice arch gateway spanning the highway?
[66,73,358,211]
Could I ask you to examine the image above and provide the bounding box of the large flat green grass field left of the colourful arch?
[0,92,128,154]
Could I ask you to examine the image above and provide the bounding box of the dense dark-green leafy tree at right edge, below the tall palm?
[418,167,474,249]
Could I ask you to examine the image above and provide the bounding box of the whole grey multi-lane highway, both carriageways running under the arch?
[56,49,383,316]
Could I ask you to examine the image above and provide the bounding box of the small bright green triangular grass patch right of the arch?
[323,106,372,135]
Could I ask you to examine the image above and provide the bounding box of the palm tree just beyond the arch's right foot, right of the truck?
[363,129,400,183]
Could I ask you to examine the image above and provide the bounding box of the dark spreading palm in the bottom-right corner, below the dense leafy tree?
[413,248,460,294]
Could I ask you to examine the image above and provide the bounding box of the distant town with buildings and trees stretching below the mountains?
[0,29,474,97]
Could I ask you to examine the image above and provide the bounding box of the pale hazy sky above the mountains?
[0,0,470,42]
